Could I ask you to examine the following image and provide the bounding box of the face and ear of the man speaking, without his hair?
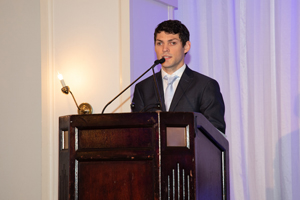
[155,31,191,74]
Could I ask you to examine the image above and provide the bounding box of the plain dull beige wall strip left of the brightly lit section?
[0,0,42,200]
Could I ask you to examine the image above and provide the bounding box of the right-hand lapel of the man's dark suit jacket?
[169,66,194,111]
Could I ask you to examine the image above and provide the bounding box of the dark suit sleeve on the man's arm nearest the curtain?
[200,79,226,133]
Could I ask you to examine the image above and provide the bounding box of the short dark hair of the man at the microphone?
[154,20,190,47]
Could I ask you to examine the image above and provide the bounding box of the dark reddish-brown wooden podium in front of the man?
[59,112,230,200]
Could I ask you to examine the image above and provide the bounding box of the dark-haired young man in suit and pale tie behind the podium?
[132,20,226,133]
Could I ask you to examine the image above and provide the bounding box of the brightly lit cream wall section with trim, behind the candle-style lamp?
[41,0,130,199]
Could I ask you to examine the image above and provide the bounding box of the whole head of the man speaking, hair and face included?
[154,20,191,74]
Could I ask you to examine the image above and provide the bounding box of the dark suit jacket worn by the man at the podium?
[131,66,226,133]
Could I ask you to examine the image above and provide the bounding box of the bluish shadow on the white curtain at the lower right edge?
[266,94,300,200]
